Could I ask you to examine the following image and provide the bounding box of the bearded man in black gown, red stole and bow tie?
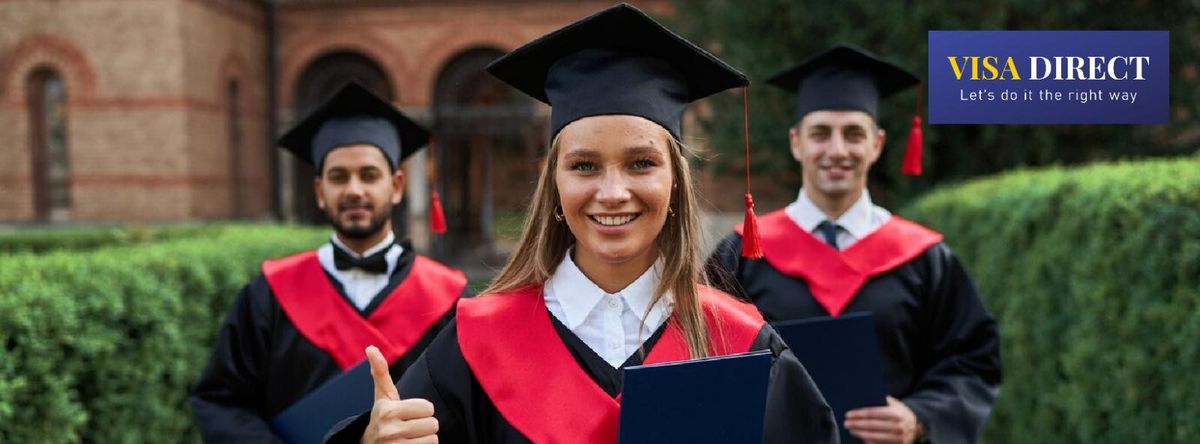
[190,83,468,443]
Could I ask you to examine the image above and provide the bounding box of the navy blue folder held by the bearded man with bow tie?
[270,360,374,444]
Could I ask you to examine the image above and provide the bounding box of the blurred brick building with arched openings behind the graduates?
[0,0,671,261]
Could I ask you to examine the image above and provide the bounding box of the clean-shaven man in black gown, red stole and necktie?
[708,46,1001,444]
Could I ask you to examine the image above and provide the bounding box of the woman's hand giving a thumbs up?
[362,346,438,444]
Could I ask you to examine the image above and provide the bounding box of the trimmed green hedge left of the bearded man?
[0,226,326,443]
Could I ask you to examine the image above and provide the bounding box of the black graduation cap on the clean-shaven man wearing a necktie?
[767,44,920,120]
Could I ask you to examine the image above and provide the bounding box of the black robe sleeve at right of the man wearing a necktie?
[901,244,1001,444]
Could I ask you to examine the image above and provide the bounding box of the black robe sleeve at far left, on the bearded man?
[188,276,280,443]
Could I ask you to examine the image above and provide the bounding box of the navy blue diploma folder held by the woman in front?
[618,350,775,444]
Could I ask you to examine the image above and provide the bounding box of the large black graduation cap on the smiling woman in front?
[487,4,750,138]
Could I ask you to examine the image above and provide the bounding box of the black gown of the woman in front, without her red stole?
[325,296,838,444]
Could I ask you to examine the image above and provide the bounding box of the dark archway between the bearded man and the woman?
[433,48,545,261]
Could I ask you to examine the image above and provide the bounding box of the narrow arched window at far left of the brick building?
[26,68,71,222]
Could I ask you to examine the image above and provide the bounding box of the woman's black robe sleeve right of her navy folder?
[750,325,838,444]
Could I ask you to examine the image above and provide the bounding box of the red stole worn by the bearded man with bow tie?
[263,251,467,371]
